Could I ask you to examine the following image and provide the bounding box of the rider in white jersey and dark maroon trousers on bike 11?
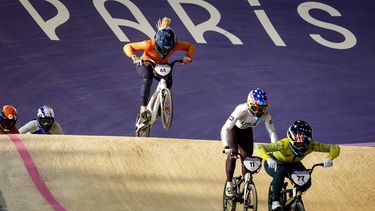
[221,88,277,197]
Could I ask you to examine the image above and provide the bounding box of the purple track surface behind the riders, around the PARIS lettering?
[0,0,375,144]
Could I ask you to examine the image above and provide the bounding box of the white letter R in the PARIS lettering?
[168,0,243,45]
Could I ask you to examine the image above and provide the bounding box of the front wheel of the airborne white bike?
[160,89,173,129]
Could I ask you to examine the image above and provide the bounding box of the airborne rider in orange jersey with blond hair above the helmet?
[123,17,195,122]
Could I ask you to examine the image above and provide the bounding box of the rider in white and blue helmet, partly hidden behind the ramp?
[20,105,64,135]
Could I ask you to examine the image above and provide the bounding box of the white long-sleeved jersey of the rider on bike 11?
[221,103,277,146]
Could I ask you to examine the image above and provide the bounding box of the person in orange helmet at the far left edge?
[0,105,19,134]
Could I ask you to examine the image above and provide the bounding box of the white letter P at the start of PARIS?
[20,0,70,40]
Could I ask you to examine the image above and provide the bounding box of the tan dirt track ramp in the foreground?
[0,135,375,211]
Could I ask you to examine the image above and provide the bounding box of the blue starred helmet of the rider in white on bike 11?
[247,88,268,117]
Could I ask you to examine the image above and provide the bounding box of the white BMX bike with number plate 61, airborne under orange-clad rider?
[135,60,182,137]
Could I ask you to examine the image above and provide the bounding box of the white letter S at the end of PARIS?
[297,2,357,49]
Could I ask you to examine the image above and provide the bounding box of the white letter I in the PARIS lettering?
[248,0,286,46]
